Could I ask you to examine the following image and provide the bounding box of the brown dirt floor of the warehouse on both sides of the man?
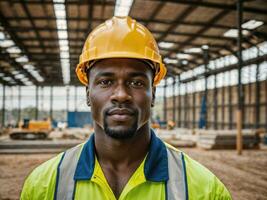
[0,148,267,200]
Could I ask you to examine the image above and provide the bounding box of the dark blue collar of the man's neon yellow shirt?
[74,130,169,182]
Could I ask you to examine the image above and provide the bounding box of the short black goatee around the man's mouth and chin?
[104,110,138,140]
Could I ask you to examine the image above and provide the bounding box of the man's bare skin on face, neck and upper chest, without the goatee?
[87,58,155,199]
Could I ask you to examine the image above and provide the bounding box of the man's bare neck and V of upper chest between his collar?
[95,124,151,199]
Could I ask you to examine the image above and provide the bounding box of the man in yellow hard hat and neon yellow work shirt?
[21,17,231,200]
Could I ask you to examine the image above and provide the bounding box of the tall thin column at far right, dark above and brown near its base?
[236,0,244,155]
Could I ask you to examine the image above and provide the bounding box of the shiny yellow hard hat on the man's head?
[76,17,167,85]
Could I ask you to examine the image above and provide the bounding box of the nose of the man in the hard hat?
[111,84,132,103]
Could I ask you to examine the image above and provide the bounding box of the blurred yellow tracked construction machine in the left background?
[9,119,52,140]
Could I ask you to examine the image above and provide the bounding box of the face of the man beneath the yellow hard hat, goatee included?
[87,58,154,139]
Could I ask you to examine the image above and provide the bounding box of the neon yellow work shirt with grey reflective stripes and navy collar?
[21,131,231,200]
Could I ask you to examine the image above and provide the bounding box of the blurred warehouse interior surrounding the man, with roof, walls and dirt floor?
[0,0,267,199]
